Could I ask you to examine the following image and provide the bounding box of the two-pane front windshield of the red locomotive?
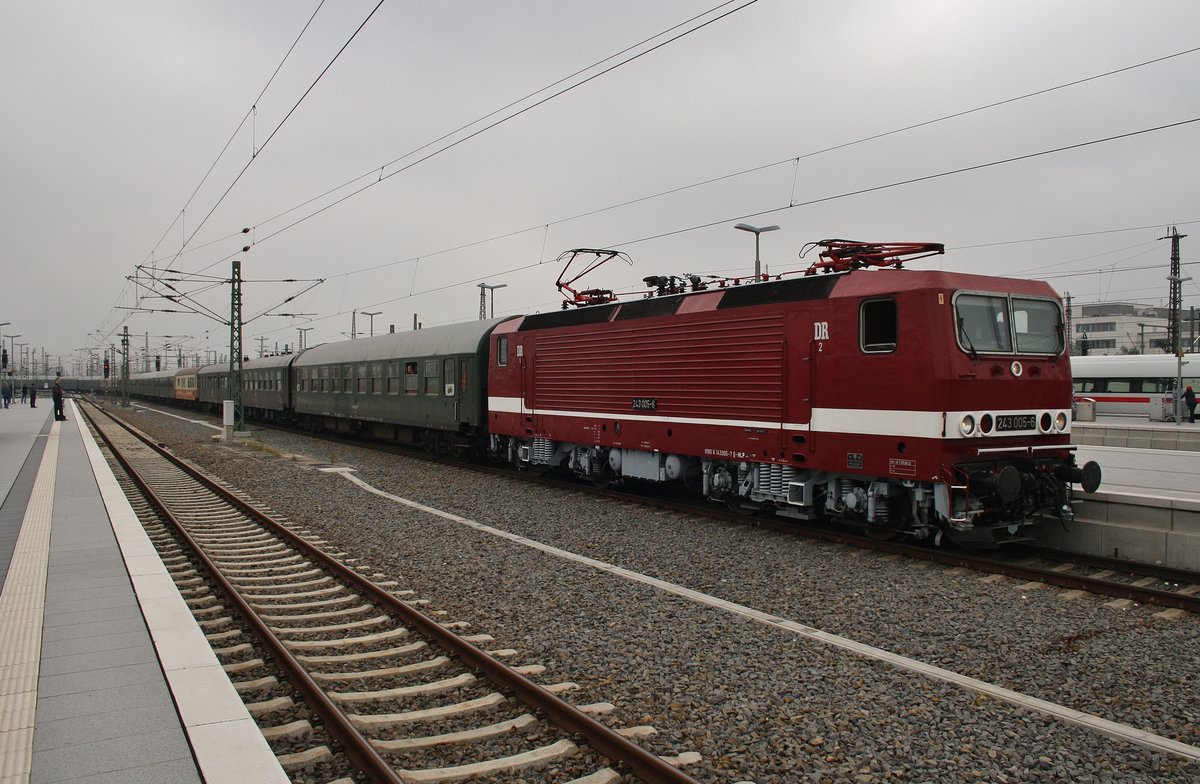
[954,294,1062,354]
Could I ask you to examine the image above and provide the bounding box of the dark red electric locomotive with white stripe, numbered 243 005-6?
[487,240,1100,544]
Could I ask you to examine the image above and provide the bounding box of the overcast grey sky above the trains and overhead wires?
[0,0,1200,370]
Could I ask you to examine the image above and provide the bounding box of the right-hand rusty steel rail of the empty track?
[84,401,698,784]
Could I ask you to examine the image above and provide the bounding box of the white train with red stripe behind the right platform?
[1070,354,1200,417]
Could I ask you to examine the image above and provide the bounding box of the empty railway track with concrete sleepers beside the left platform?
[82,406,694,784]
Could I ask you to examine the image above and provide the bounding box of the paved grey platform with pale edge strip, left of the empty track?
[0,400,288,784]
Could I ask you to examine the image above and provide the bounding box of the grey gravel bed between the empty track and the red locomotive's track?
[117,409,1200,784]
